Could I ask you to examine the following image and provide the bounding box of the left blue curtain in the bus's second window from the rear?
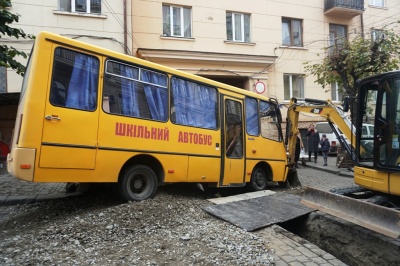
[120,65,140,117]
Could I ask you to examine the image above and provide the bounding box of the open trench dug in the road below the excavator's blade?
[279,211,400,266]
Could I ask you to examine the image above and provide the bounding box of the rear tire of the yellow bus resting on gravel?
[118,165,158,201]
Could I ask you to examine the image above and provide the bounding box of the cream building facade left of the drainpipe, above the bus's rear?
[2,0,132,92]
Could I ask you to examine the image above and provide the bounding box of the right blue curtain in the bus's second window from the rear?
[141,69,168,121]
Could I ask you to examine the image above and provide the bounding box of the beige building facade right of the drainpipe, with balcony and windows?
[132,0,400,120]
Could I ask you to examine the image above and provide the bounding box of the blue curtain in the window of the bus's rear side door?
[65,53,99,111]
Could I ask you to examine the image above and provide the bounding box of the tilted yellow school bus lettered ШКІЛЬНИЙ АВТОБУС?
[7,32,288,201]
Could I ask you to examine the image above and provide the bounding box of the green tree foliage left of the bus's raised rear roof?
[0,0,34,76]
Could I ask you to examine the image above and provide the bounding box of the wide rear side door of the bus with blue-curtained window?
[39,47,100,169]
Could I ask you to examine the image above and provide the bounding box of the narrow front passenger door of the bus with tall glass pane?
[220,96,245,186]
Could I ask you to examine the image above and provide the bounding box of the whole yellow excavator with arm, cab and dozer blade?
[287,71,400,238]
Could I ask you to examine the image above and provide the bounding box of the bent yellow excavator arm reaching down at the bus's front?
[286,98,356,168]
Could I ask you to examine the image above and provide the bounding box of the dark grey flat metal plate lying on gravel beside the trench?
[203,193,314,231]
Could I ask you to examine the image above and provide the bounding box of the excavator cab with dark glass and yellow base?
[355,71,400,195]
